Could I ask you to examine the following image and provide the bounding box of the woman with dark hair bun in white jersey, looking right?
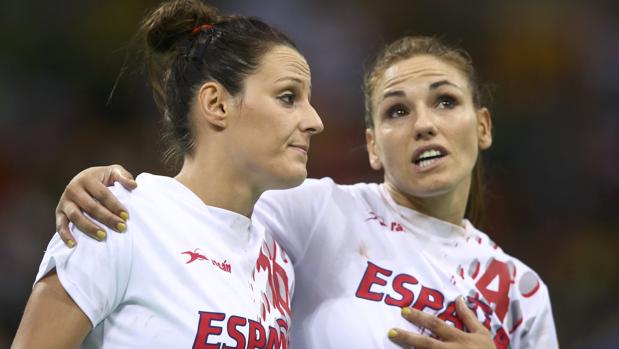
[13,0,323,348]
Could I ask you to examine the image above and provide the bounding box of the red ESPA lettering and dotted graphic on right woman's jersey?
[355,258,540,349]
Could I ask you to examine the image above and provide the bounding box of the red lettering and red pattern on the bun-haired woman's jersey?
[193,237,291,349]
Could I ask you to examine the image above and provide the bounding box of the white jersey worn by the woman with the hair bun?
[37,174,294,348]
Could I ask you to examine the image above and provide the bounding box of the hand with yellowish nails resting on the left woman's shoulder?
[56,165,137,248]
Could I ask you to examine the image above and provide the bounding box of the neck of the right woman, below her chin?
[384,181,471,226]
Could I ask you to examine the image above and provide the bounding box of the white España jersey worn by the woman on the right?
[254,178,558,349]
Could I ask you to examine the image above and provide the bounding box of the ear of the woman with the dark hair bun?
[198,81,232,129]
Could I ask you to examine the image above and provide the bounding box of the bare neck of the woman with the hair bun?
[175,154,262,217]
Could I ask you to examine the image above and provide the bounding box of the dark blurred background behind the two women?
[0,0,619,348]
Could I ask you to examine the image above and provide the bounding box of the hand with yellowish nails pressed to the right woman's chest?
[388,297,496,349]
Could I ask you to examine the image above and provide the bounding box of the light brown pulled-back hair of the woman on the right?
[363,36,485,225]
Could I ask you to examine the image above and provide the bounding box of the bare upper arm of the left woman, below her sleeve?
[11,270,92,349]
